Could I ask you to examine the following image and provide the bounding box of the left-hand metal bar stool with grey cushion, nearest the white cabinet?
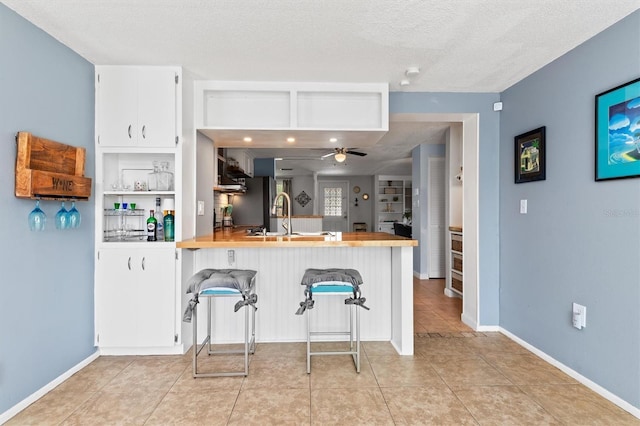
[183,269,258,378]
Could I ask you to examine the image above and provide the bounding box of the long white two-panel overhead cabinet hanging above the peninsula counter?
[194,81,389,148]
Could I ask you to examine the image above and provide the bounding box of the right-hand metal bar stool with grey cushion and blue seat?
[296,269,369,373]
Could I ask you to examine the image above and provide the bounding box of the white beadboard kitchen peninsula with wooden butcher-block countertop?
[176,228,417,355]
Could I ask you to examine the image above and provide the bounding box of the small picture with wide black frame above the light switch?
[514,126,547,183]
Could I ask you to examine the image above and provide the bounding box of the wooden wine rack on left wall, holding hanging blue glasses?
[16,132,91,201]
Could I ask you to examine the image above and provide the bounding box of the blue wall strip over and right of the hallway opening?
[389,92,500,326]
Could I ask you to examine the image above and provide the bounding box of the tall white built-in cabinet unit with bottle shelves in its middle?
[95,66,189,355]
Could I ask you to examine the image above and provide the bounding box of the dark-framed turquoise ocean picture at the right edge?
[595,78,640,181]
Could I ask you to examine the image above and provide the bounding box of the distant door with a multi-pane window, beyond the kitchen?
[318,181,349,232]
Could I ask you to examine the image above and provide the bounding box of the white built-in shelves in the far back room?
[375,175,411,234]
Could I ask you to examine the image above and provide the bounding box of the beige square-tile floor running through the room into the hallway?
[7,280,640,425]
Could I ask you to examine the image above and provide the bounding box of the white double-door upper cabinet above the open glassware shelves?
[96,66,179,148]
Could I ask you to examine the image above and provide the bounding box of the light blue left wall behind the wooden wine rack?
[0,4,95,413]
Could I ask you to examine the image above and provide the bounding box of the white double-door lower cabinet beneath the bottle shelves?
[95,248,176,348]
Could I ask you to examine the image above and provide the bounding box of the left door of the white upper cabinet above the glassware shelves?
[96,67,138,146]
